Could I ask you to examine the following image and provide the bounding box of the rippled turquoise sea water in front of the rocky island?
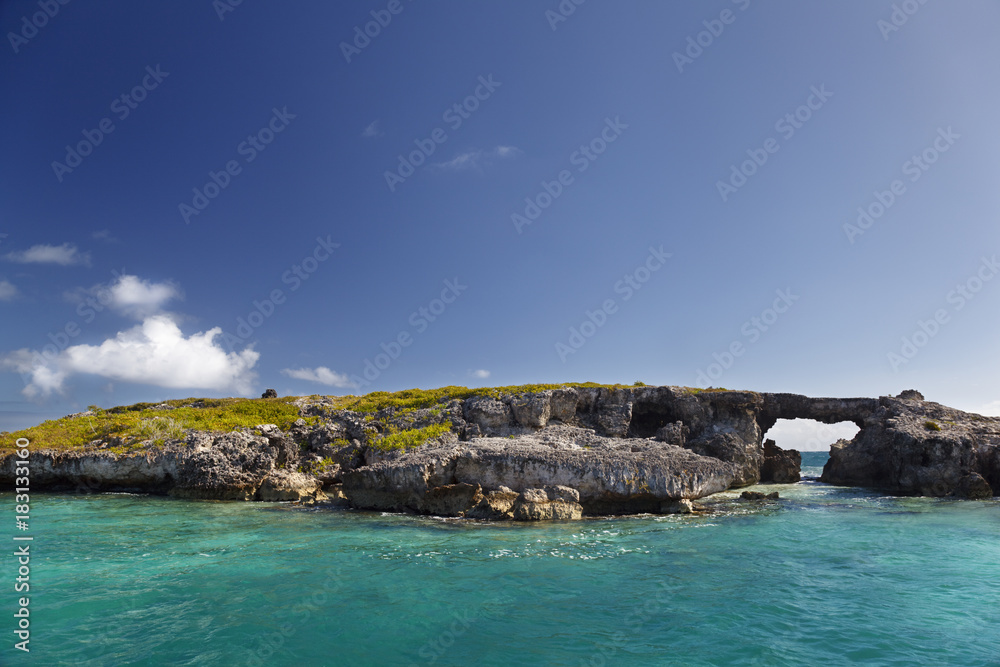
[7,454,1000,667]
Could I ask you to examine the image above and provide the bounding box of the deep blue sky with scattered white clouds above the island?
[0,0,1000,444]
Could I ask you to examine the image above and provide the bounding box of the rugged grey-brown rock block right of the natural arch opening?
[820,397,1000,496]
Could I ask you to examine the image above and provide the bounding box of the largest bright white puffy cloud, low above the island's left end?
[2,315,260,398]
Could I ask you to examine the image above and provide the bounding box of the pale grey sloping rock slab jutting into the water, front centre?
[343,426,735,518]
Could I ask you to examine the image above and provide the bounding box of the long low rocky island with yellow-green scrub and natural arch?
[0,383,1000,520]
